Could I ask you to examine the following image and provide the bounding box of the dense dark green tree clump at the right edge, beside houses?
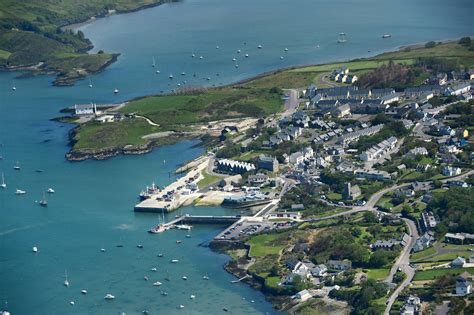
[427,187,474,235]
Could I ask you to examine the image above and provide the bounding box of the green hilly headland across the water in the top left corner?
[0,0,167,85]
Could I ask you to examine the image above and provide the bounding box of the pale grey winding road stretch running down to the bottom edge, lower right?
[384,218,419,315]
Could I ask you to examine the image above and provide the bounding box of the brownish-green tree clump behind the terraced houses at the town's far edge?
[356,61,419,88]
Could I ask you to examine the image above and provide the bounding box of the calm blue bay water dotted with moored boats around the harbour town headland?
[0,0,473,314]
